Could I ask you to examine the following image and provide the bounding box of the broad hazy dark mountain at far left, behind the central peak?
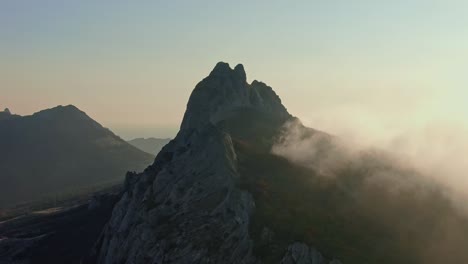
[0,105,152,207]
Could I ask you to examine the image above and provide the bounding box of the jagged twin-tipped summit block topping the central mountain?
[181,62,289,129]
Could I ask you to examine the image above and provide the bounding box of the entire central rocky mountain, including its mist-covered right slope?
[94,63,468,264]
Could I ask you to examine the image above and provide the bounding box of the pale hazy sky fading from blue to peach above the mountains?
[0,0,468,138]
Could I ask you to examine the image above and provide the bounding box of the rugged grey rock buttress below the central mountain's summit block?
[93,127,254,263]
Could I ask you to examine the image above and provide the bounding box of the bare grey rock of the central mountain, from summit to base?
[95,62,336,263]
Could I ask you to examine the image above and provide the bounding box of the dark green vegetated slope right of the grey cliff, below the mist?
[234,140,468,264]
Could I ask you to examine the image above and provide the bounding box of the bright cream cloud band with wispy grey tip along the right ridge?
[272,114,468,202]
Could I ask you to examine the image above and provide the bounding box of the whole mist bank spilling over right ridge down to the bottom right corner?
[272,120,468,264]
